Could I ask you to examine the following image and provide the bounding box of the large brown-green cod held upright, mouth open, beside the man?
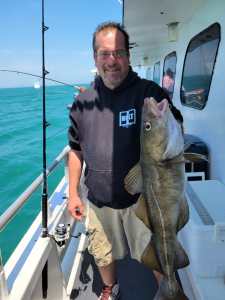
[125,98,189,300]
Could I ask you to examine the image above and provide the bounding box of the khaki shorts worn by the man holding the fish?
[86,201,151,267]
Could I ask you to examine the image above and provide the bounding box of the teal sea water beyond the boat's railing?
[0,85,87,262]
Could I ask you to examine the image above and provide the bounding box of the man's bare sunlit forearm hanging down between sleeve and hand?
[68,150,83,198]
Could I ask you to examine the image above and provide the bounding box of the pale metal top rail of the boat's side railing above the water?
[0,146,70,231]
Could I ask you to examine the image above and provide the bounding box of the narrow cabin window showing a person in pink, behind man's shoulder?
[162,51,177,99]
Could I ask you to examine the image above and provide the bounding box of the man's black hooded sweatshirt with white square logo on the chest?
[68,70,182,209]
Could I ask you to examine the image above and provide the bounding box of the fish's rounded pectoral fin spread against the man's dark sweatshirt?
[124,163,143,195]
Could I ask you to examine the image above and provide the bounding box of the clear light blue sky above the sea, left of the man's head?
[0,0,122,88]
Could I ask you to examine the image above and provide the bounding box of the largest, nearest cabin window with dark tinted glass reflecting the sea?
[180,23,220,109]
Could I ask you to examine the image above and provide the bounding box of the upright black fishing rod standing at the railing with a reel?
[41,0,49,299]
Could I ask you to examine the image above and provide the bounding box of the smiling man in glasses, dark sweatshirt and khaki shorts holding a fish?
[68,22,182,300]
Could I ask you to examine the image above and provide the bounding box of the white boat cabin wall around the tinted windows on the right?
[135,0,225,183]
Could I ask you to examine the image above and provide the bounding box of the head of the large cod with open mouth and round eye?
[141,98,183,161]
